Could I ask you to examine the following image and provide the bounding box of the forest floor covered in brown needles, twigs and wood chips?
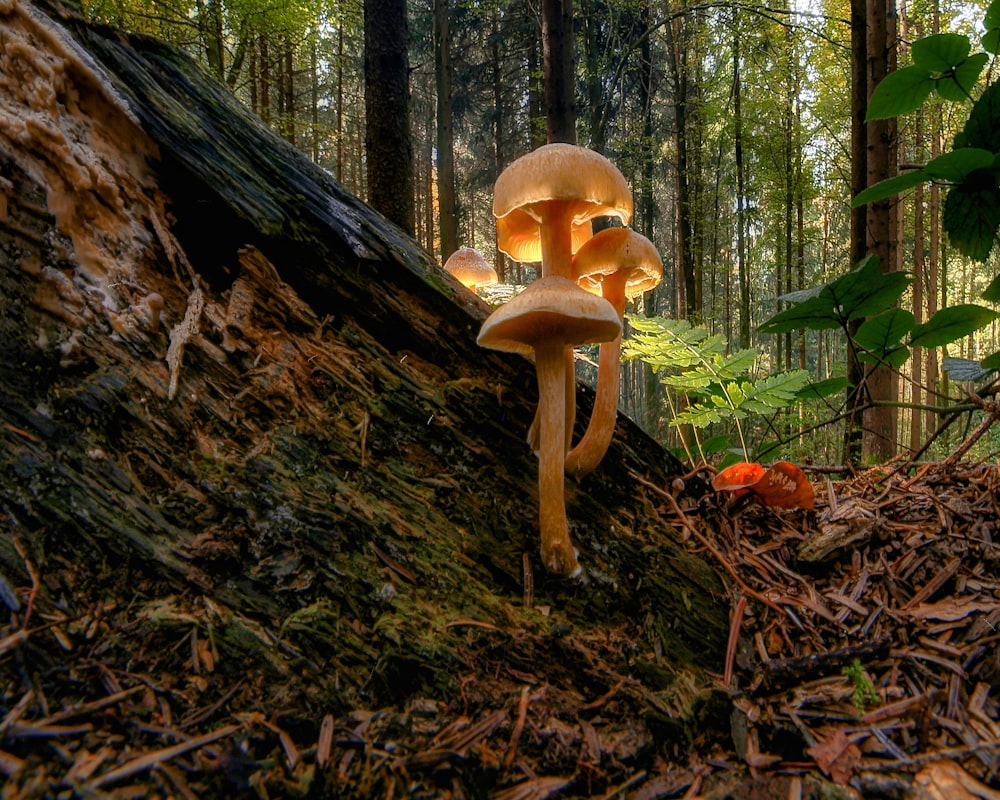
[0,456,1000,800]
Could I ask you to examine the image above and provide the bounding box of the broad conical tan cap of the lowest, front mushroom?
[476,275,622,355]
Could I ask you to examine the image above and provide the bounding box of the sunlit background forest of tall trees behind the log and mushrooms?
[85,0,1000,464]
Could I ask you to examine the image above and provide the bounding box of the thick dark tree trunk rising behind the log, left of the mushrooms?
[364,0,414,234]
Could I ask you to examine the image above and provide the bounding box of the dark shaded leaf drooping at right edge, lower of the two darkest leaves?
[941,177,1000,261]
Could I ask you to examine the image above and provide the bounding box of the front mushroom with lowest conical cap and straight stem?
[478,275,621,576]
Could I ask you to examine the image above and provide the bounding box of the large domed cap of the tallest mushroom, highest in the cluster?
[493,143,632,261]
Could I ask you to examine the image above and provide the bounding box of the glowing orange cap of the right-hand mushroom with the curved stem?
[573,228,663,297]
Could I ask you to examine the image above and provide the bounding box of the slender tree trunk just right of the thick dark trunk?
[434,0,458,264]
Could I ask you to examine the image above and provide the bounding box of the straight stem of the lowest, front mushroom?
[535,341,582,577]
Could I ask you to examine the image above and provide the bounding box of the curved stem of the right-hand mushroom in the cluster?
[566,272,625,480]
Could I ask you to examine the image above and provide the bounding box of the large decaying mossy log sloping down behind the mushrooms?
[0,0,728,796]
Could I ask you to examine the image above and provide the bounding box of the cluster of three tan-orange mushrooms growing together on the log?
[470,144,663,576]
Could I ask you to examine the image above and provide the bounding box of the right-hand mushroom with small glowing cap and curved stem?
[566,228,663,480]
